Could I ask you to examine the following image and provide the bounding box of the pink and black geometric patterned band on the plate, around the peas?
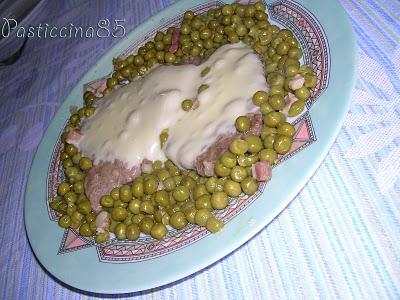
[46,1,330,263]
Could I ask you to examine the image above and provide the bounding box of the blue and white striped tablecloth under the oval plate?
[0,0,400,299]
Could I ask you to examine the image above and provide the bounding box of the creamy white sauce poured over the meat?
[78,42,268,169]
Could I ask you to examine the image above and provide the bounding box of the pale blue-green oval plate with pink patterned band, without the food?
[24,0,355,293]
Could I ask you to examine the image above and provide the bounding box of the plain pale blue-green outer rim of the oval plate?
[24,0,356,293]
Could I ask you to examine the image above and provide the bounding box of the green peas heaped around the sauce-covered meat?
[50,2,317,243]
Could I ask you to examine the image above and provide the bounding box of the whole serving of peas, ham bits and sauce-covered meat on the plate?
[49,2,317,243]
